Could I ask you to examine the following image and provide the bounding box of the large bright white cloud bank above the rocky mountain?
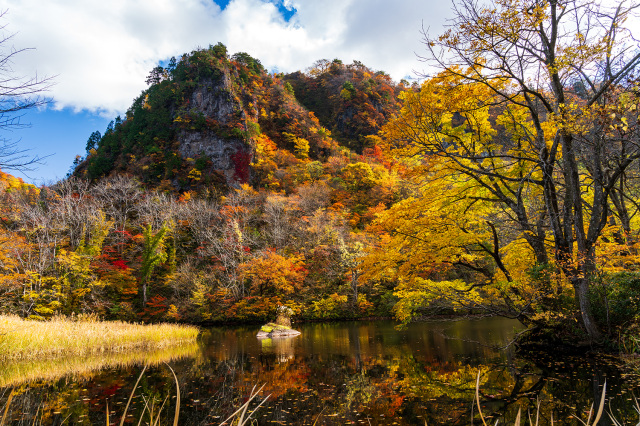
[3,0,449,115]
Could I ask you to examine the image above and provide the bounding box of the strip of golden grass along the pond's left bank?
[0,315,199,361]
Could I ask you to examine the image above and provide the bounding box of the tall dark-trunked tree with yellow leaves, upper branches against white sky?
[376,0,640,340]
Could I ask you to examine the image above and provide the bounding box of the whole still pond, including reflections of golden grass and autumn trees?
[0,318,640,425]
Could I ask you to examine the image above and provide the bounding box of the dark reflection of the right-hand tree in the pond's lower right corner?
[430,354,637,425]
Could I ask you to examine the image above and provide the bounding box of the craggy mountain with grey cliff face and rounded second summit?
[74,43,402,193]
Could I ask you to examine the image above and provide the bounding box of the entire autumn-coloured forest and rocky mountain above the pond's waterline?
[0,5,640,350]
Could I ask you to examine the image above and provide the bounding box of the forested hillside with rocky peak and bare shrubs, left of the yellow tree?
[2,44,401,322]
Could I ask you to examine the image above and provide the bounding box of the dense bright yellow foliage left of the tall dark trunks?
[368,68,572,322]
